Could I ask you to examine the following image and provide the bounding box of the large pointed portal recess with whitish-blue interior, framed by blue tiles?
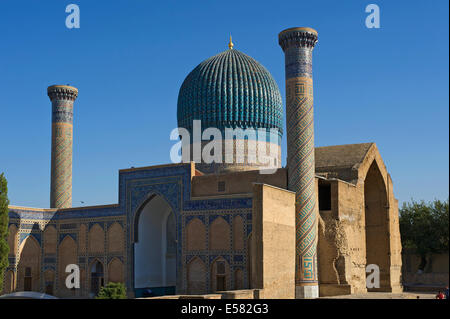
[134,195,177,297]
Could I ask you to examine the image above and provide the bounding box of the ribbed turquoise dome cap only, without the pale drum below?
[177,49,283,136]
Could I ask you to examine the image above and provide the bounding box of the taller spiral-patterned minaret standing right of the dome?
[278,28,319,298]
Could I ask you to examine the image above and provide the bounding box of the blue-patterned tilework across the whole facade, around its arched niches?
[9,164,252,298]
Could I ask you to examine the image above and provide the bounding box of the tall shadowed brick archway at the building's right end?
[364,161,390,291]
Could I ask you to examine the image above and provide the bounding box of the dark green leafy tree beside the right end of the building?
[400,199,449,270]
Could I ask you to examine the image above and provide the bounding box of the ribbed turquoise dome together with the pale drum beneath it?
[177,48,283,173]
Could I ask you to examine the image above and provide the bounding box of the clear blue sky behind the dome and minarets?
[0,0,449,207]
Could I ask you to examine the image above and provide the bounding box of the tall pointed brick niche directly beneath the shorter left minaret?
[58,235,78,297]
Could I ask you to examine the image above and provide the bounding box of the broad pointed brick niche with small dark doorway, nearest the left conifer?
[17,235,41,291]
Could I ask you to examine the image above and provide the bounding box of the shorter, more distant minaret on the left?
[47,85,78,208]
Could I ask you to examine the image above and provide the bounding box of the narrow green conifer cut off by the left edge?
[0,173,9,291]
